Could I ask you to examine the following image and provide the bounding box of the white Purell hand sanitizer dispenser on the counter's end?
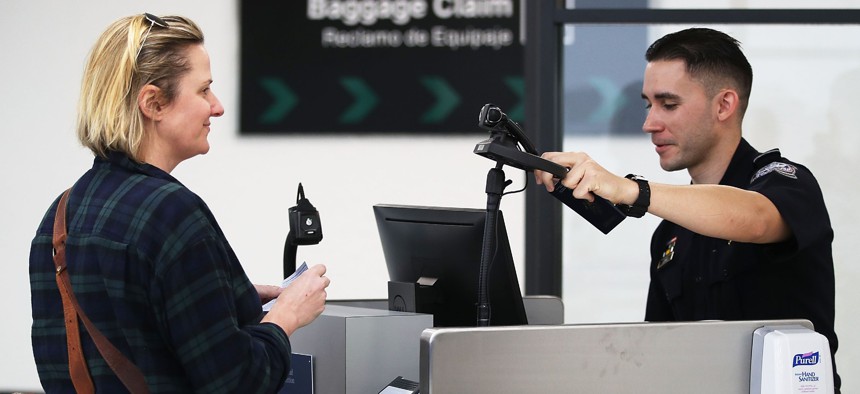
[750,325,833,394]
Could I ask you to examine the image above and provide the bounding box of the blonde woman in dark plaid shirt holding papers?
[30,14,329,392]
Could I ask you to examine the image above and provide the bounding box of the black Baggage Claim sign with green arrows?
[240,0,525,134]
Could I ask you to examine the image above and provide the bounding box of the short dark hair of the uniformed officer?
[645,28,752,116]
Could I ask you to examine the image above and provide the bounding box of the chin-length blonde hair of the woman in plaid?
[77,15,203,161]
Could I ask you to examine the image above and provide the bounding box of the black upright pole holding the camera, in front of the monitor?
[477,162,511,327]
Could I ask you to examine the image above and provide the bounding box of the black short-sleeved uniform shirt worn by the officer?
[645,139,839,387]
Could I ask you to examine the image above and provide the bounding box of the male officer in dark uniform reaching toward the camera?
[535,28,840,393]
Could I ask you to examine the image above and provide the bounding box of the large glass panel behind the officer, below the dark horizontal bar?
[562,23,860,324]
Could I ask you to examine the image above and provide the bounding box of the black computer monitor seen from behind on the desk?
[373,204,527,327]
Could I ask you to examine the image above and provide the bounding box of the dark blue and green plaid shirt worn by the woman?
[30,152,290,393]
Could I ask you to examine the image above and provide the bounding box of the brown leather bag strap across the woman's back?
[53,189,149,393]
